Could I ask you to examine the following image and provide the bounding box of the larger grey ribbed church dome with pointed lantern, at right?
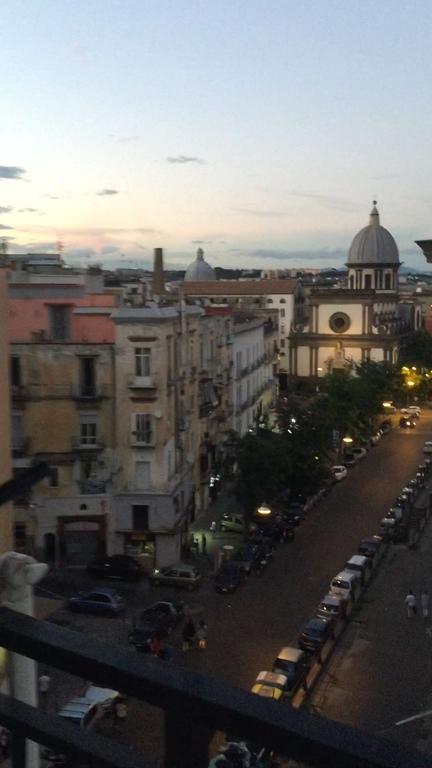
[347,200,400,267]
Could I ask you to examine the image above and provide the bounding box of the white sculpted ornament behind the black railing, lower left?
[0,552,48,768]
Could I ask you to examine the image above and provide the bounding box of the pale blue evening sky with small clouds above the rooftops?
[0,0,432,269]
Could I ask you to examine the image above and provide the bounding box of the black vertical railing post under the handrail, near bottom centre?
[164,709,214,768]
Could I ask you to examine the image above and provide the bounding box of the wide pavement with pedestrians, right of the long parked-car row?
[310,480,432,753]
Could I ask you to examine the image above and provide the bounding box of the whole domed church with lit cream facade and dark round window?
[289,202,421,378]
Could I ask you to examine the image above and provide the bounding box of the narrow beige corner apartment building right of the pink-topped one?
[112,302,202,566]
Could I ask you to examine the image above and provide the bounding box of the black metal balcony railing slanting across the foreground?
[0,608,432,768]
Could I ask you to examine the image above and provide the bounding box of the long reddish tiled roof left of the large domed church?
[183,279,297,296]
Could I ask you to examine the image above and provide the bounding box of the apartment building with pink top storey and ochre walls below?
[8,261,117,563]
